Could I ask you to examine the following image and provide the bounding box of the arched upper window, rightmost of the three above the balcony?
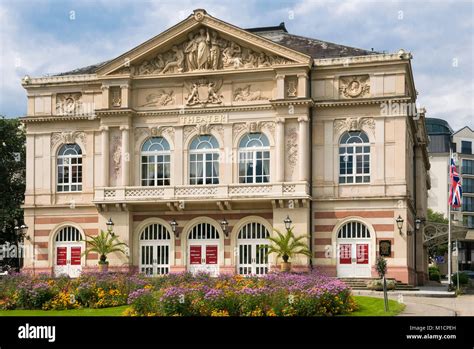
[239,133,270,183]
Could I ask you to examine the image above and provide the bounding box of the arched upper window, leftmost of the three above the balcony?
[141,137,170,186]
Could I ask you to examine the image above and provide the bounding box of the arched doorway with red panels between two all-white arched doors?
[188,223,219,276]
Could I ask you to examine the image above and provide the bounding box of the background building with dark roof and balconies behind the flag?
[426,118,474,271]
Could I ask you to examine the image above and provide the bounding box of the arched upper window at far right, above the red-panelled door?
[339,131,370,184]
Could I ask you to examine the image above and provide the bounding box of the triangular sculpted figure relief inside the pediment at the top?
[133,27,291,75]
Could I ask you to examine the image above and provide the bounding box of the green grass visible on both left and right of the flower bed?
[0,296,405,317]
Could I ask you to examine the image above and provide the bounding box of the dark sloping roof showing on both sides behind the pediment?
[55,22,380,76]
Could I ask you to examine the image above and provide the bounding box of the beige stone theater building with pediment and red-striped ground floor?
[22,9,429,284]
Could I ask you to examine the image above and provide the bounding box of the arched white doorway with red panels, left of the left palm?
[54,226,84,278]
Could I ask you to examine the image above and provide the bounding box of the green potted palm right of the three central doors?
[262,227,311,272]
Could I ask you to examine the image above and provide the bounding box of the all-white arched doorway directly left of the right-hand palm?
[237,222,270,275]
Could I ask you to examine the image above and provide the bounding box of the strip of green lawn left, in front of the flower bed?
[0,305,128,316]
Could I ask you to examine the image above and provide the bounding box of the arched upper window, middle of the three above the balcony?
[189,136,219,184]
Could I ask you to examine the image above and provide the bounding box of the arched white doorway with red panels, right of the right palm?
[337,221,372,277]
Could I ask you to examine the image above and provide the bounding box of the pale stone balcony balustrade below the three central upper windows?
[94,182,309,203]
